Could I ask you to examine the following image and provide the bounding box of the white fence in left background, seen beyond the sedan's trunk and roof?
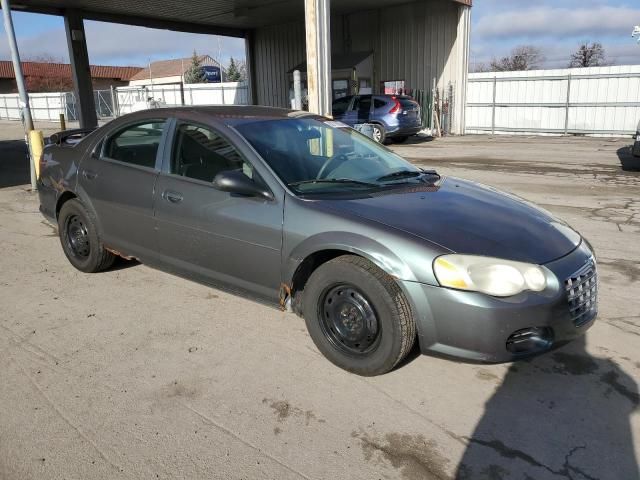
[0,82,250,121]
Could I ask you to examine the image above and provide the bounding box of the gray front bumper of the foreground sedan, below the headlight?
[402,242,596,363]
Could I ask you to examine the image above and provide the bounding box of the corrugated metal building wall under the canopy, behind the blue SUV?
[254,0,468,131]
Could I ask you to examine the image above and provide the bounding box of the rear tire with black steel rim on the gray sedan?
[58,198,116,273]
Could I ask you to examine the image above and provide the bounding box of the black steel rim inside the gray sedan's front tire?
[318,284,380,355]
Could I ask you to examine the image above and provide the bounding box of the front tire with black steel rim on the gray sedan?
[303,255,416,376]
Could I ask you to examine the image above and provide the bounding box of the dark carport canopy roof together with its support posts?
[2,0,471,127]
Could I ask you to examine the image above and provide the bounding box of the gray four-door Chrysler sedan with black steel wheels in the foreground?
[39,107,597,375]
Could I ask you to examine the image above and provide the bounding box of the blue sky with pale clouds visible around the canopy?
[0,0,640,68]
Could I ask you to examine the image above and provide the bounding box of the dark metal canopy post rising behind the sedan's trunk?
[64,11,98,128]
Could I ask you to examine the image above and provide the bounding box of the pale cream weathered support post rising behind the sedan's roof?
[304,0,331,117]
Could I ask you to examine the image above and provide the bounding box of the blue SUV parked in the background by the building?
[332,95,423,143]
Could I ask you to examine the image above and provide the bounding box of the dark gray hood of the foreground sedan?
[320,177,581,264]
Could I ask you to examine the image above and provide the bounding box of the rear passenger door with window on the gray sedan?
[78,118,167,259]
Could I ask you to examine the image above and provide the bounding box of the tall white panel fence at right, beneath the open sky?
[466,65,640,136]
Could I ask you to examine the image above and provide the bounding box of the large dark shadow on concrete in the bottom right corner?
[455,338,640,480]
